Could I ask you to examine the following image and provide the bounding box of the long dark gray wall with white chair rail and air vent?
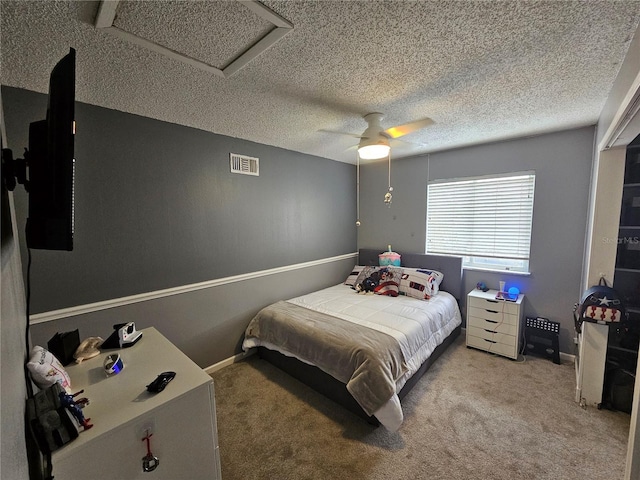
[2,87,356,366]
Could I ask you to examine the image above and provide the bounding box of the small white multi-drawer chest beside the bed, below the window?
[467,290,524,359]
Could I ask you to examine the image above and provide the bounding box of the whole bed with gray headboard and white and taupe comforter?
[243,249,462,431]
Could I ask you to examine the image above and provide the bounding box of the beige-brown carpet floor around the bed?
[212,335,630,480]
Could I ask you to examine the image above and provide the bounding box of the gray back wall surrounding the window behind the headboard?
[358,127,594,354]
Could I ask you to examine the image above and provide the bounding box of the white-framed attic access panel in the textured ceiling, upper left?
[95,0,293,77]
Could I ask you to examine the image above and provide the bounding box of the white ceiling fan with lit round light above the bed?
[325,112,433,160]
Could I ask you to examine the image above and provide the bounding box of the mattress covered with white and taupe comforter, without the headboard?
[243,284,462,431]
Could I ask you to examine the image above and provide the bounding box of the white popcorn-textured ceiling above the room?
[0,0,640,163]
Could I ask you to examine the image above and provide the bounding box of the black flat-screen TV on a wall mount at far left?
[2,48,76,251]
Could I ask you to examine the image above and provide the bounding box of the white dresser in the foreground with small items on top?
[52,328,221,480]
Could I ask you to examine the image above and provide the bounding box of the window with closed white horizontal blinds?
[426,172,535,272]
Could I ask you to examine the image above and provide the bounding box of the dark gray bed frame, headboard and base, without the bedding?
[258,249,463,426]
